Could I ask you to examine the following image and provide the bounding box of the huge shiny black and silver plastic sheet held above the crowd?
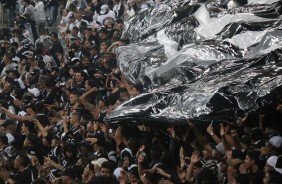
[105,1,282,124]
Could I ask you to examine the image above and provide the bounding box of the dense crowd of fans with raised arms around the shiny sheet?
[0,0,282,184]
